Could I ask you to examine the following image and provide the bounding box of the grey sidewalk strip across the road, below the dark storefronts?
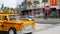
[34,18,60,24]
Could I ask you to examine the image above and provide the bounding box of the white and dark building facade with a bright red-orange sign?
[15,0,60,18]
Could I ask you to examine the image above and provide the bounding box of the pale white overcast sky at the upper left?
[0,0,24,8]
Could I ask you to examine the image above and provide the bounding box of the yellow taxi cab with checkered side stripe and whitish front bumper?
[0,14,35,34]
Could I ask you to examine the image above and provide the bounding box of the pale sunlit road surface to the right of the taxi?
[33,23,60,34]
